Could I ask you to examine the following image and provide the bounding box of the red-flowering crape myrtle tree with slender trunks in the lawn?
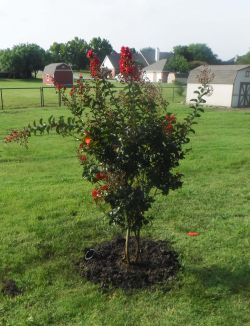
[5,47,208,264]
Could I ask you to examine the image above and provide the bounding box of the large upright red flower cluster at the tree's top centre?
[119,46,141,81]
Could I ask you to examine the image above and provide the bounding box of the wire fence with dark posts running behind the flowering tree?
[0,85,186,110]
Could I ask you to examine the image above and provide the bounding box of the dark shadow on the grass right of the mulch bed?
[192,264,250,296]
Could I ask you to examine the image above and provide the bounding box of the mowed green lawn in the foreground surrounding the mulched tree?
[0,105,250,326]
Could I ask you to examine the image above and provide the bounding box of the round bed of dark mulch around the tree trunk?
[79,237,180,289]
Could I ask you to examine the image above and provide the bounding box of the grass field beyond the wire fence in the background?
[0,78,185,110]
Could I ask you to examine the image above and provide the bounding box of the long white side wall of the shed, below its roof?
[186,84,233,107]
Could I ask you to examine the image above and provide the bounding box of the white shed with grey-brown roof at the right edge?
[186,65,250,108]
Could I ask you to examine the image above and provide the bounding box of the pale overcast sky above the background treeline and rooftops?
[0,0,250,60]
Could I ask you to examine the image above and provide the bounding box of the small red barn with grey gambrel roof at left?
[43,63,73,86]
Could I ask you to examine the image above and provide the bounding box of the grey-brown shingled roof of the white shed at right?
[187,65,250,84]
